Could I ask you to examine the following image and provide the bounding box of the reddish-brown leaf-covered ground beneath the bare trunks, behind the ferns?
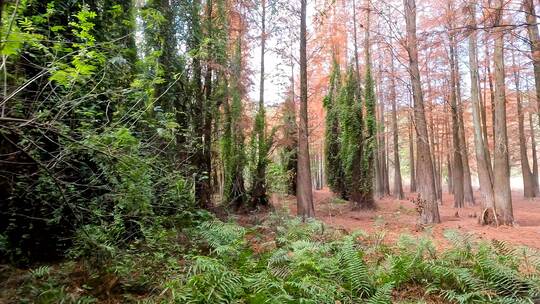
[272,189,540,249]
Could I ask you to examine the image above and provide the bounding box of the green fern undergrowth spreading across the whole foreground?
[0,213,540,304]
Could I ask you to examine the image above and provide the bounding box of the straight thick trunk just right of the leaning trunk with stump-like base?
[493,0,514,225]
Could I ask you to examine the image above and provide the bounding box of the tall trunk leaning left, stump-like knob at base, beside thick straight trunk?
[468,0,495,224]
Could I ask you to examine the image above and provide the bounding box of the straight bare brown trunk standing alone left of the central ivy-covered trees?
[296,0,315,218]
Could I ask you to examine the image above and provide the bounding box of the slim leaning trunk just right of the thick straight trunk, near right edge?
[512,51,535,198]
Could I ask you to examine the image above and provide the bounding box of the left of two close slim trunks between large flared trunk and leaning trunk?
[449,34,464,208]
